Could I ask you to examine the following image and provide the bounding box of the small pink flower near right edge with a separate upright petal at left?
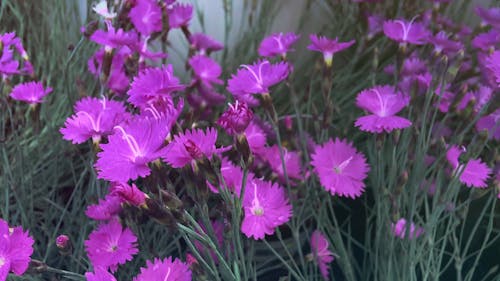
[446,145,492,188]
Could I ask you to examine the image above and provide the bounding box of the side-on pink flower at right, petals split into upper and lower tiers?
[355,86,411,133]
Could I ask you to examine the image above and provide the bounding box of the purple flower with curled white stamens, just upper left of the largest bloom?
[60,97,129,144]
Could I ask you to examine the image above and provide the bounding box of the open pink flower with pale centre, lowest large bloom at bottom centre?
[241,179,292,240]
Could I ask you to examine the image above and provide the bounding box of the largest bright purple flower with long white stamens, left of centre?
[95,117,170,183]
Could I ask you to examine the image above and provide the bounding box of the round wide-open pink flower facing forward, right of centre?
[311,139,370,198]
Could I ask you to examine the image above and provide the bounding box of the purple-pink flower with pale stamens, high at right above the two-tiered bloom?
[383,19,430,45]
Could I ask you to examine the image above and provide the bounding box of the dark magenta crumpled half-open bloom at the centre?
[217,101,253,135]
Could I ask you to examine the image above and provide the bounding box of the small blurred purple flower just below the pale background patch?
[189,55,223,87]
